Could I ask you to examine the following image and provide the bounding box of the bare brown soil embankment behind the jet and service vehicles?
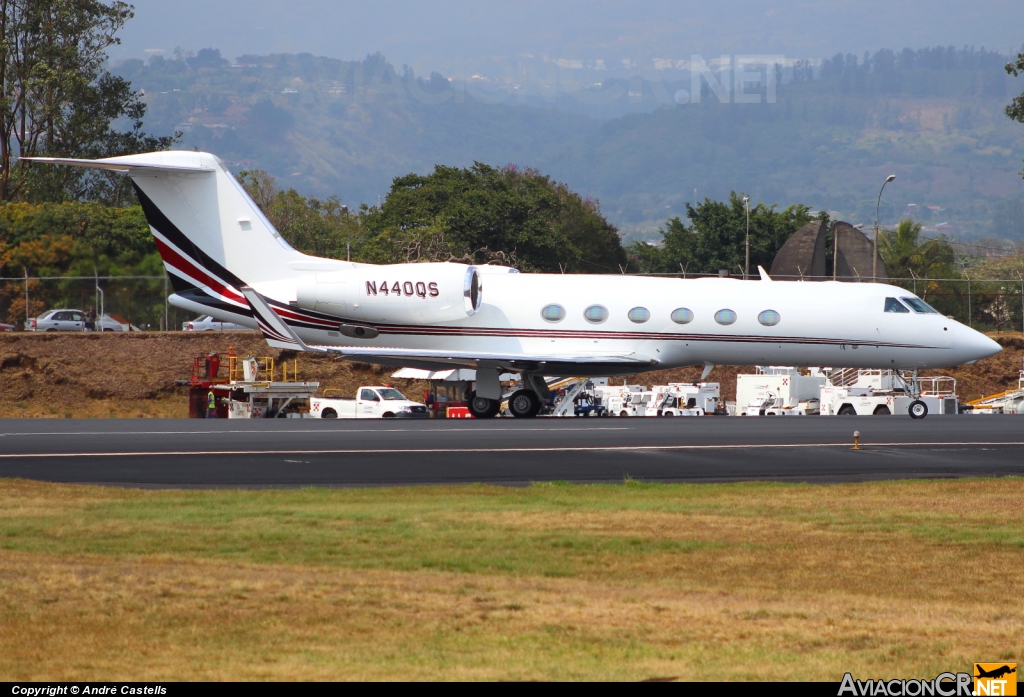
[0,332,1024,419]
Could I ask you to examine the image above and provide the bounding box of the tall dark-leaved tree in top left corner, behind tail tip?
[0,0,173,204]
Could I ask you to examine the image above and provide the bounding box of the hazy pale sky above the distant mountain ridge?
[110,0,1024,74]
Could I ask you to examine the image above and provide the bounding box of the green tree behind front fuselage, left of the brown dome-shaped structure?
[630,191,813,275]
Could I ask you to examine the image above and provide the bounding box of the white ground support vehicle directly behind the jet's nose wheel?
[820,368,958,419]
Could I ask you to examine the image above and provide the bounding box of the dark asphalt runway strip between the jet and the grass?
[0,416,1024,488]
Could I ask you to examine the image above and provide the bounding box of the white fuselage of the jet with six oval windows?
[176,265,1000,375]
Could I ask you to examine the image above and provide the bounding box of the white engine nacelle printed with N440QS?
[296,263,483,324]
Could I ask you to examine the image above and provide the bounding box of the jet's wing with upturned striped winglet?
[240,286,657,372]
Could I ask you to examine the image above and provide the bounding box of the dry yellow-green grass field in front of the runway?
[0,479,1024,681]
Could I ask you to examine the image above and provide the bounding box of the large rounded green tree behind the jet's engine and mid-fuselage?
[362,163,626,273]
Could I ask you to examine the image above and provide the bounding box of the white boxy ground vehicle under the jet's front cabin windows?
[736,365,826,417]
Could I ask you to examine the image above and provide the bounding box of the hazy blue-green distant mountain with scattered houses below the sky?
[116,48,1024,238]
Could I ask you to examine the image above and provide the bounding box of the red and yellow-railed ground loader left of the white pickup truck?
[175,352,319,419]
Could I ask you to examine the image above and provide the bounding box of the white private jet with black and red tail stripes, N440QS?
[25,151,1001,418]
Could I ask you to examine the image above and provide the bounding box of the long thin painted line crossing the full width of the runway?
[0,441,1024,460]
